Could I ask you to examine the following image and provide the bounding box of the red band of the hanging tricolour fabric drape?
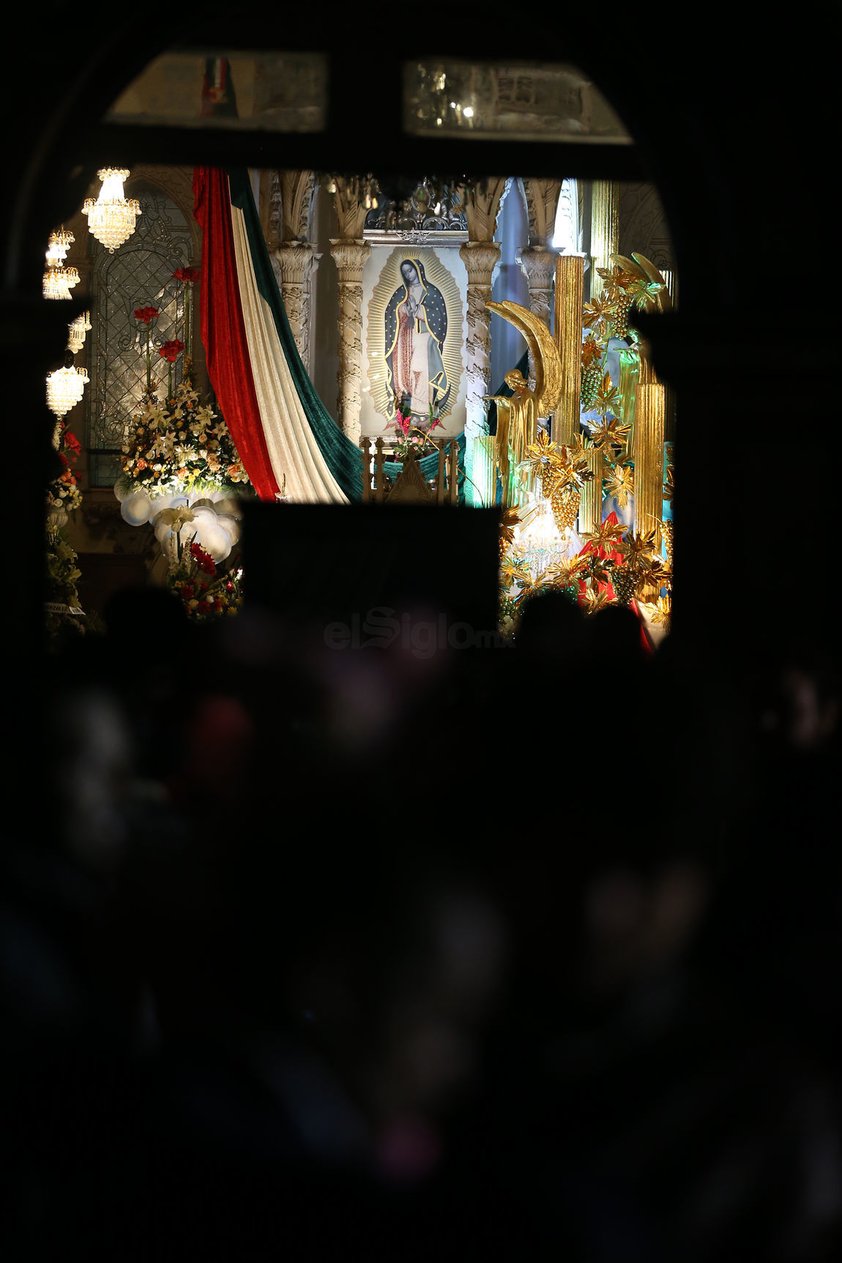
[193,167,279,500]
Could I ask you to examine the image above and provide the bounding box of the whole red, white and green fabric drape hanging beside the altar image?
[193,167,362,504]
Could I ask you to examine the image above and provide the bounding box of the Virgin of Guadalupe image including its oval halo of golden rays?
[367,245,463,433]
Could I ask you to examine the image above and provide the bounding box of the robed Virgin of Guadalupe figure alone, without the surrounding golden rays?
[384,258,452,423]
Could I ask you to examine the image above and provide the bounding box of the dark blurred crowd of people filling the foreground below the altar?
[0,543,842,1263]
